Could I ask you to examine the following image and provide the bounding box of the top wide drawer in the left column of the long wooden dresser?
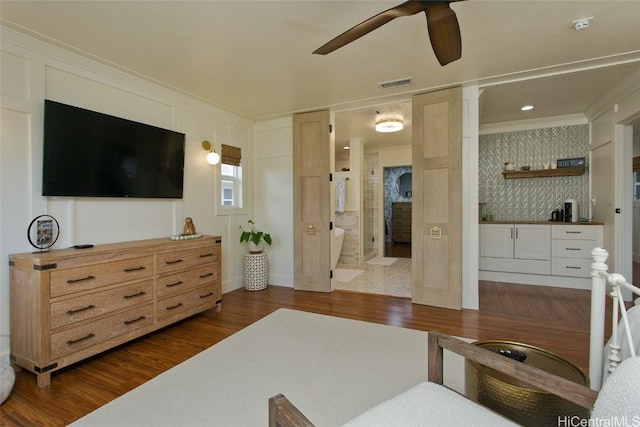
[50,256,153,298]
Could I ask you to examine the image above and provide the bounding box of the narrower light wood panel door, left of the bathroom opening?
[293,111,333,292]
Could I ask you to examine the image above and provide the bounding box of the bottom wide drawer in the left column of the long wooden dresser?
[51,304,153,360]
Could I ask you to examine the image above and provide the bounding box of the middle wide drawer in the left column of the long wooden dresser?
[51,280,153,329]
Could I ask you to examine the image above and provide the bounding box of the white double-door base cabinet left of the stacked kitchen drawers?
[480,224,551,274]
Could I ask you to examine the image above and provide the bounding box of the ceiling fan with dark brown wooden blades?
[313,0,463,65]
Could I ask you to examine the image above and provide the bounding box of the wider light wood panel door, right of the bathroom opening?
[411,88,462,309]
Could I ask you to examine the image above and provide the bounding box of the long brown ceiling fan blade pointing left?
[313,0,431,55]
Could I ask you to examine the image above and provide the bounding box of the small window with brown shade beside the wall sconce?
[220,144,243,211]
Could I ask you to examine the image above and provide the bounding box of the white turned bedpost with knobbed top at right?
[589,248,609,391]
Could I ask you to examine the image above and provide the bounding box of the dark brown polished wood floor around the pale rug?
[0,282,600,426]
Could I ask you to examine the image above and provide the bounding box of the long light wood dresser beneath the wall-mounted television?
[9,236,222,387]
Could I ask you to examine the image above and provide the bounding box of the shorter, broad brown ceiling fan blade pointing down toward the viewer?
[424,3,462,65]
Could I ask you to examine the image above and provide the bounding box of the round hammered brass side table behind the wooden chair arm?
[465,340,590,427]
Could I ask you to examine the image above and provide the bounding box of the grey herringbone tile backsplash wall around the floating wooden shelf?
[478,125,589,221]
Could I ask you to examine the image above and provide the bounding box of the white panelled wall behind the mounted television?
[0,28,255,360]
